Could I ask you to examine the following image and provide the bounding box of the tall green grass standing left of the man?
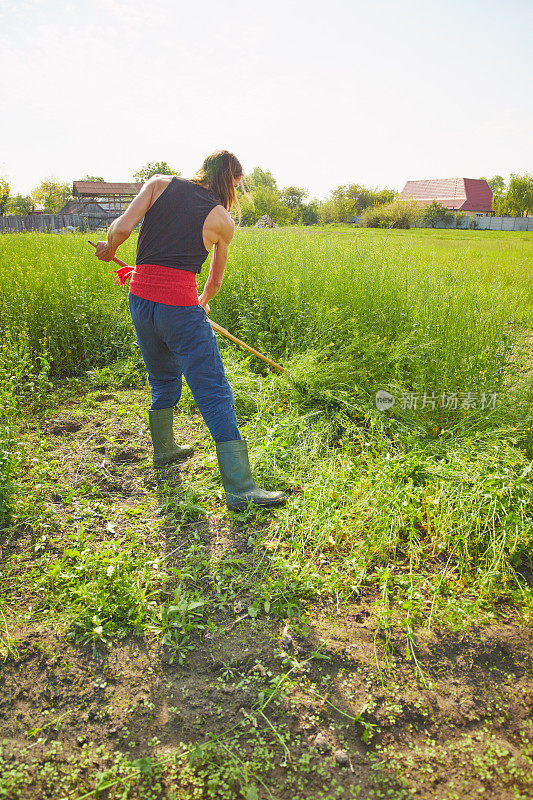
[0,233,132,374]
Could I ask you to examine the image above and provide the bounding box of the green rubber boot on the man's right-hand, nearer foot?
[216,439,286,511]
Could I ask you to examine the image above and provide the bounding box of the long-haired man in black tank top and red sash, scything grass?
[96,150,285,510]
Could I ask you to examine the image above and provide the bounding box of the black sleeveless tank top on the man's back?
[136,178,221,273]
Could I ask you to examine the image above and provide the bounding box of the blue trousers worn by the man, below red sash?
[128,292,241,442]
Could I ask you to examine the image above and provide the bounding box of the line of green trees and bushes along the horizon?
[0,161,533,225]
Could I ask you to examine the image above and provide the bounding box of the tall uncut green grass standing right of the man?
[218,230,533,390]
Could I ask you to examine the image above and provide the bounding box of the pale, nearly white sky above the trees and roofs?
[0,0,533,198]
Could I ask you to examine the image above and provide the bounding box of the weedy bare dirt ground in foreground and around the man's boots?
[0,390,533,800]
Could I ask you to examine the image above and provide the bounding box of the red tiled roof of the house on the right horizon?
[400,178,492,211]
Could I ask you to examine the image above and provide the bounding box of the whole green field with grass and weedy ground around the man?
[0,226,533,800]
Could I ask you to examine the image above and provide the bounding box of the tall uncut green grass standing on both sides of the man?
[0,229,533,390]
